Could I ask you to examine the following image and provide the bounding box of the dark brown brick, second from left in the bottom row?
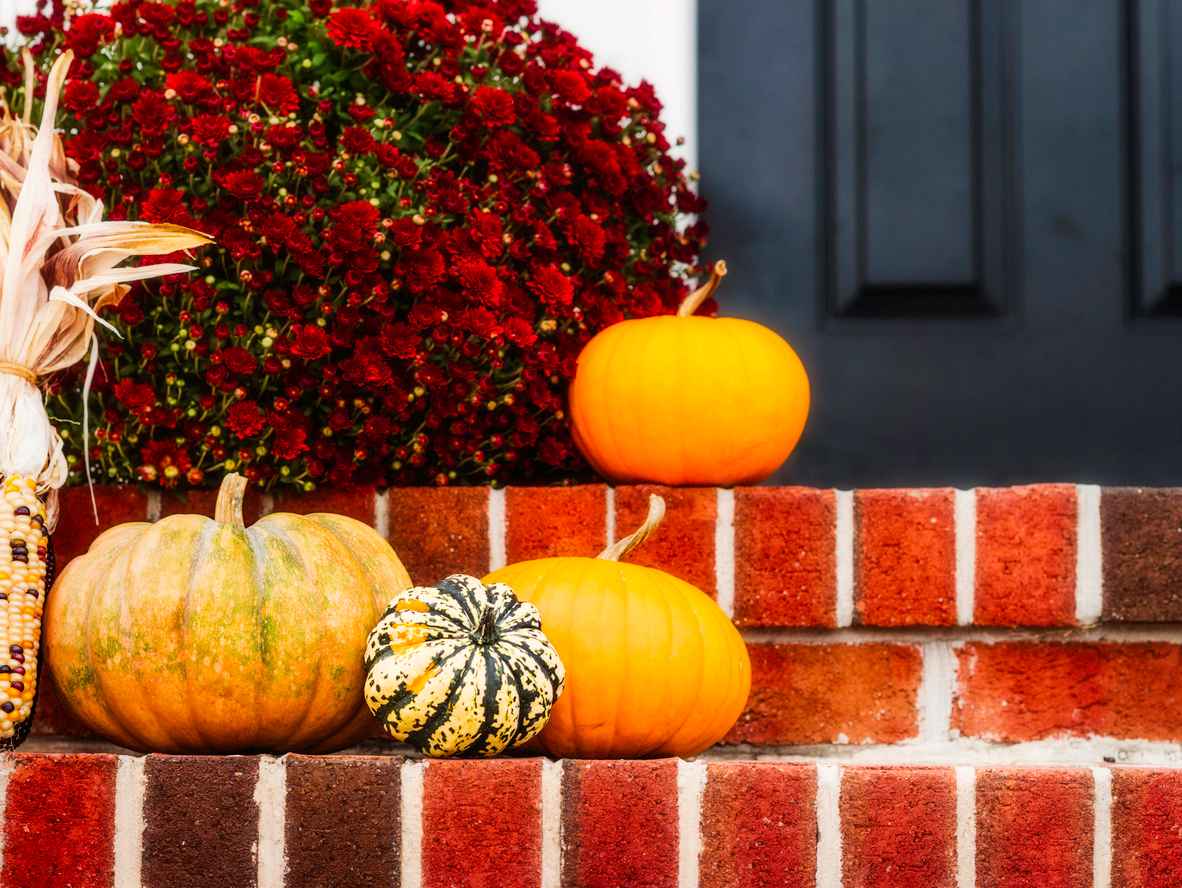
[143,756,260,888]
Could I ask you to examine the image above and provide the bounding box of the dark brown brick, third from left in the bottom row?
[285,756,402,888]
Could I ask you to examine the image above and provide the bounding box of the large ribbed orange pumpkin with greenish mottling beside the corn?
[45,474,410,753]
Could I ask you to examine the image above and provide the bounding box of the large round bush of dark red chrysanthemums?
[5,0,704,488]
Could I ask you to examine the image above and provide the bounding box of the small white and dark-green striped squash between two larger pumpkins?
[365,573,566,757]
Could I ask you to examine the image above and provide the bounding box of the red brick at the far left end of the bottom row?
[2,753,117,888]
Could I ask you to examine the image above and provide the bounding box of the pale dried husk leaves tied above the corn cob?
[0,52,209,516]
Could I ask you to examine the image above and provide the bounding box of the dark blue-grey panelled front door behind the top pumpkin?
[699,0,1182,486]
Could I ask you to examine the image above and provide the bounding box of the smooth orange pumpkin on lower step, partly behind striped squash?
[485,497,751,758]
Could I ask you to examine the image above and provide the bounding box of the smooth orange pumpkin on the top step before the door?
[570,262,808,487]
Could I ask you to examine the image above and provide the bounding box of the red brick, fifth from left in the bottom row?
[563,759,677,888]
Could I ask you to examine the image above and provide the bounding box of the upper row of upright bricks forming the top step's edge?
[54,484,1182,629]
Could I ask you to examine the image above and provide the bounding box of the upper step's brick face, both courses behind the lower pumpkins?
[37,485,1182,761]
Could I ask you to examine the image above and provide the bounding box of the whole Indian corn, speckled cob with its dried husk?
[0,52,209,750]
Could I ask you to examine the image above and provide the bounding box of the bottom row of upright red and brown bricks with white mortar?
[0,753,1182,888]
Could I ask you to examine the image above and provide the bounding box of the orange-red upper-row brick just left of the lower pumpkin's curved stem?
[505,484,608,564]
